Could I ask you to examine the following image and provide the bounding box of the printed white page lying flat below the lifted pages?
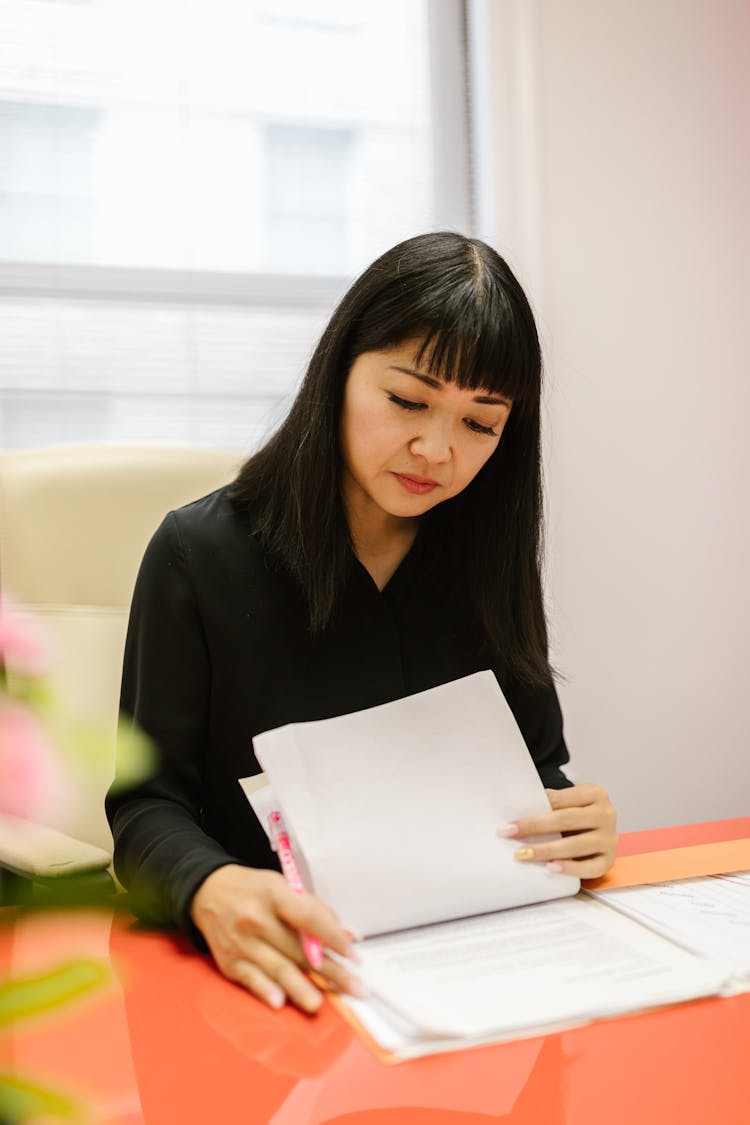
[344,896,725,1050]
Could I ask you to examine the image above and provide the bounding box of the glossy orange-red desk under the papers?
[0,818,750,1125]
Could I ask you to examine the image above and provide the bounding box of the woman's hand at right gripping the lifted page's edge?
[497,783,617,879]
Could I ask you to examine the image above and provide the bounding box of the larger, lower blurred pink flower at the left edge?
[0,696,69,821]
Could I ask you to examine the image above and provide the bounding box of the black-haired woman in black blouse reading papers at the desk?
[107,233,615,1011]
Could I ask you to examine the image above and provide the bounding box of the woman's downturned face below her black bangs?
[341,341,512,519]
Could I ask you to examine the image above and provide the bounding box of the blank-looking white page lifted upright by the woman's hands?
[249,672,579,935]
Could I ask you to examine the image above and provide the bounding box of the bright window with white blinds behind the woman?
[0,0,469,449]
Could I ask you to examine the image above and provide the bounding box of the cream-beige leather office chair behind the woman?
[0,446,243,901]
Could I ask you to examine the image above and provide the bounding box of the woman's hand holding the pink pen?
[190,864,363,1013]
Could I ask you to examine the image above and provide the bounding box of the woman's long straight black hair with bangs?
[232,232,551,683]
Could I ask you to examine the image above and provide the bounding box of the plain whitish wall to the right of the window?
[476,0,750,829]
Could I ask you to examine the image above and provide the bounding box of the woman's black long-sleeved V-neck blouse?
[107,488,570,945]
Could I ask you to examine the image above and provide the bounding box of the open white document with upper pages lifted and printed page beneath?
[243,672,750,1058]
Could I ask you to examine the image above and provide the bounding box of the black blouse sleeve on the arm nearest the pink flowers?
[106,513,236,945]
